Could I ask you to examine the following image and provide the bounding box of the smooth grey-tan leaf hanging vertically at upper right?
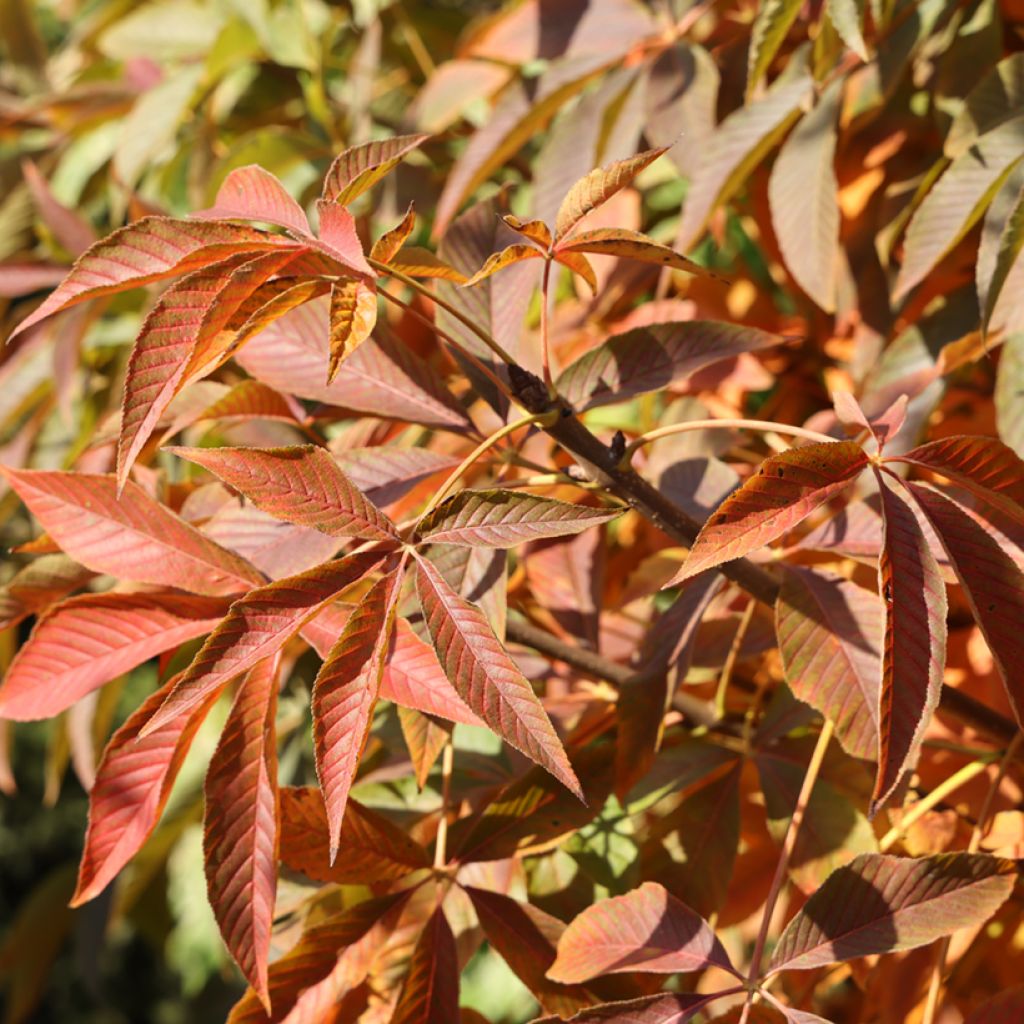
[759,81,843,312]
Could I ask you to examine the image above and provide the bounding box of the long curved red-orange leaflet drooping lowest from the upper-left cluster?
[118,246,302,486]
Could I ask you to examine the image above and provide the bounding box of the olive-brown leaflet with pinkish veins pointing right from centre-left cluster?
[417,488,622,548]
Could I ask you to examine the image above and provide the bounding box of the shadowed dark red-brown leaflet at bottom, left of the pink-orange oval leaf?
[466,887,595,1017]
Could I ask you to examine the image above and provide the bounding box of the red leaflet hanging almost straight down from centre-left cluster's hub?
[312,572,402,863]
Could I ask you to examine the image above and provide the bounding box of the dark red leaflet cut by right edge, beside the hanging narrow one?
[910,484,1024,722]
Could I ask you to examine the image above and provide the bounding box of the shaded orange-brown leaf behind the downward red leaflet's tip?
[281,785,430,885]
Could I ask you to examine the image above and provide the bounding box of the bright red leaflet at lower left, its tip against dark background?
[72,678,220,906]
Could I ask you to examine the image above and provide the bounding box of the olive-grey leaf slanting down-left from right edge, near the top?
[893,118,1024,300]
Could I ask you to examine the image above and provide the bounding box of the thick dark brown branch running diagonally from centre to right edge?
[508,364,1018,743]
